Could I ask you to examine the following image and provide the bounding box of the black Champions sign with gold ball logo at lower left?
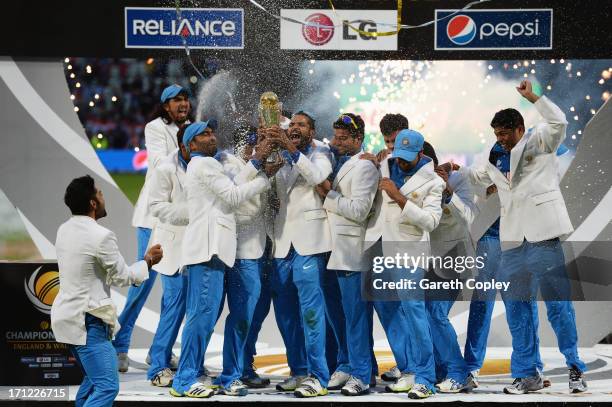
[0,262,83,386]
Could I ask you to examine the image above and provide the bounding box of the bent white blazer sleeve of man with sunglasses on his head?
[323,161,379,223]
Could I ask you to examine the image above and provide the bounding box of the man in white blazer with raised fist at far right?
[461,80,586,394]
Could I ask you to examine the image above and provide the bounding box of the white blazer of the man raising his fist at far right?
[460,96,573,250]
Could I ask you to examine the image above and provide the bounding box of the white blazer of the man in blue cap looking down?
[365,157,446,256]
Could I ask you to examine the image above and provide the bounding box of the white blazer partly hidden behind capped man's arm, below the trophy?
[221,154,267,260]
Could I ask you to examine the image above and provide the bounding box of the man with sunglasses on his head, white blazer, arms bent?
[317,113,379,396]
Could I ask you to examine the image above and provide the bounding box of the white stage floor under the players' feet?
[0,345,612,407]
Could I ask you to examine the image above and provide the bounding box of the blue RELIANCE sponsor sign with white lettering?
[124,7,244,49]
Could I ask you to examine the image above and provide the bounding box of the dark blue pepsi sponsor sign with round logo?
[435,9,553,51]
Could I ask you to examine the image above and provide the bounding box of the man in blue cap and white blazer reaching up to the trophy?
[170,122,270,398]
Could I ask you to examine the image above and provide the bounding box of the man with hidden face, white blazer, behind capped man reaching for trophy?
[147,127,191,387]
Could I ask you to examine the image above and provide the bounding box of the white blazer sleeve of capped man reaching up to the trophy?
[198,158,270,210]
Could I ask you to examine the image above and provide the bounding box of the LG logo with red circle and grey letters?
[302,13,377,45]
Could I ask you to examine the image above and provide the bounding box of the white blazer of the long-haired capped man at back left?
[132,117,178,229]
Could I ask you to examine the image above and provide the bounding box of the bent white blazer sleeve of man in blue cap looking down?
[399,176,445,232]
